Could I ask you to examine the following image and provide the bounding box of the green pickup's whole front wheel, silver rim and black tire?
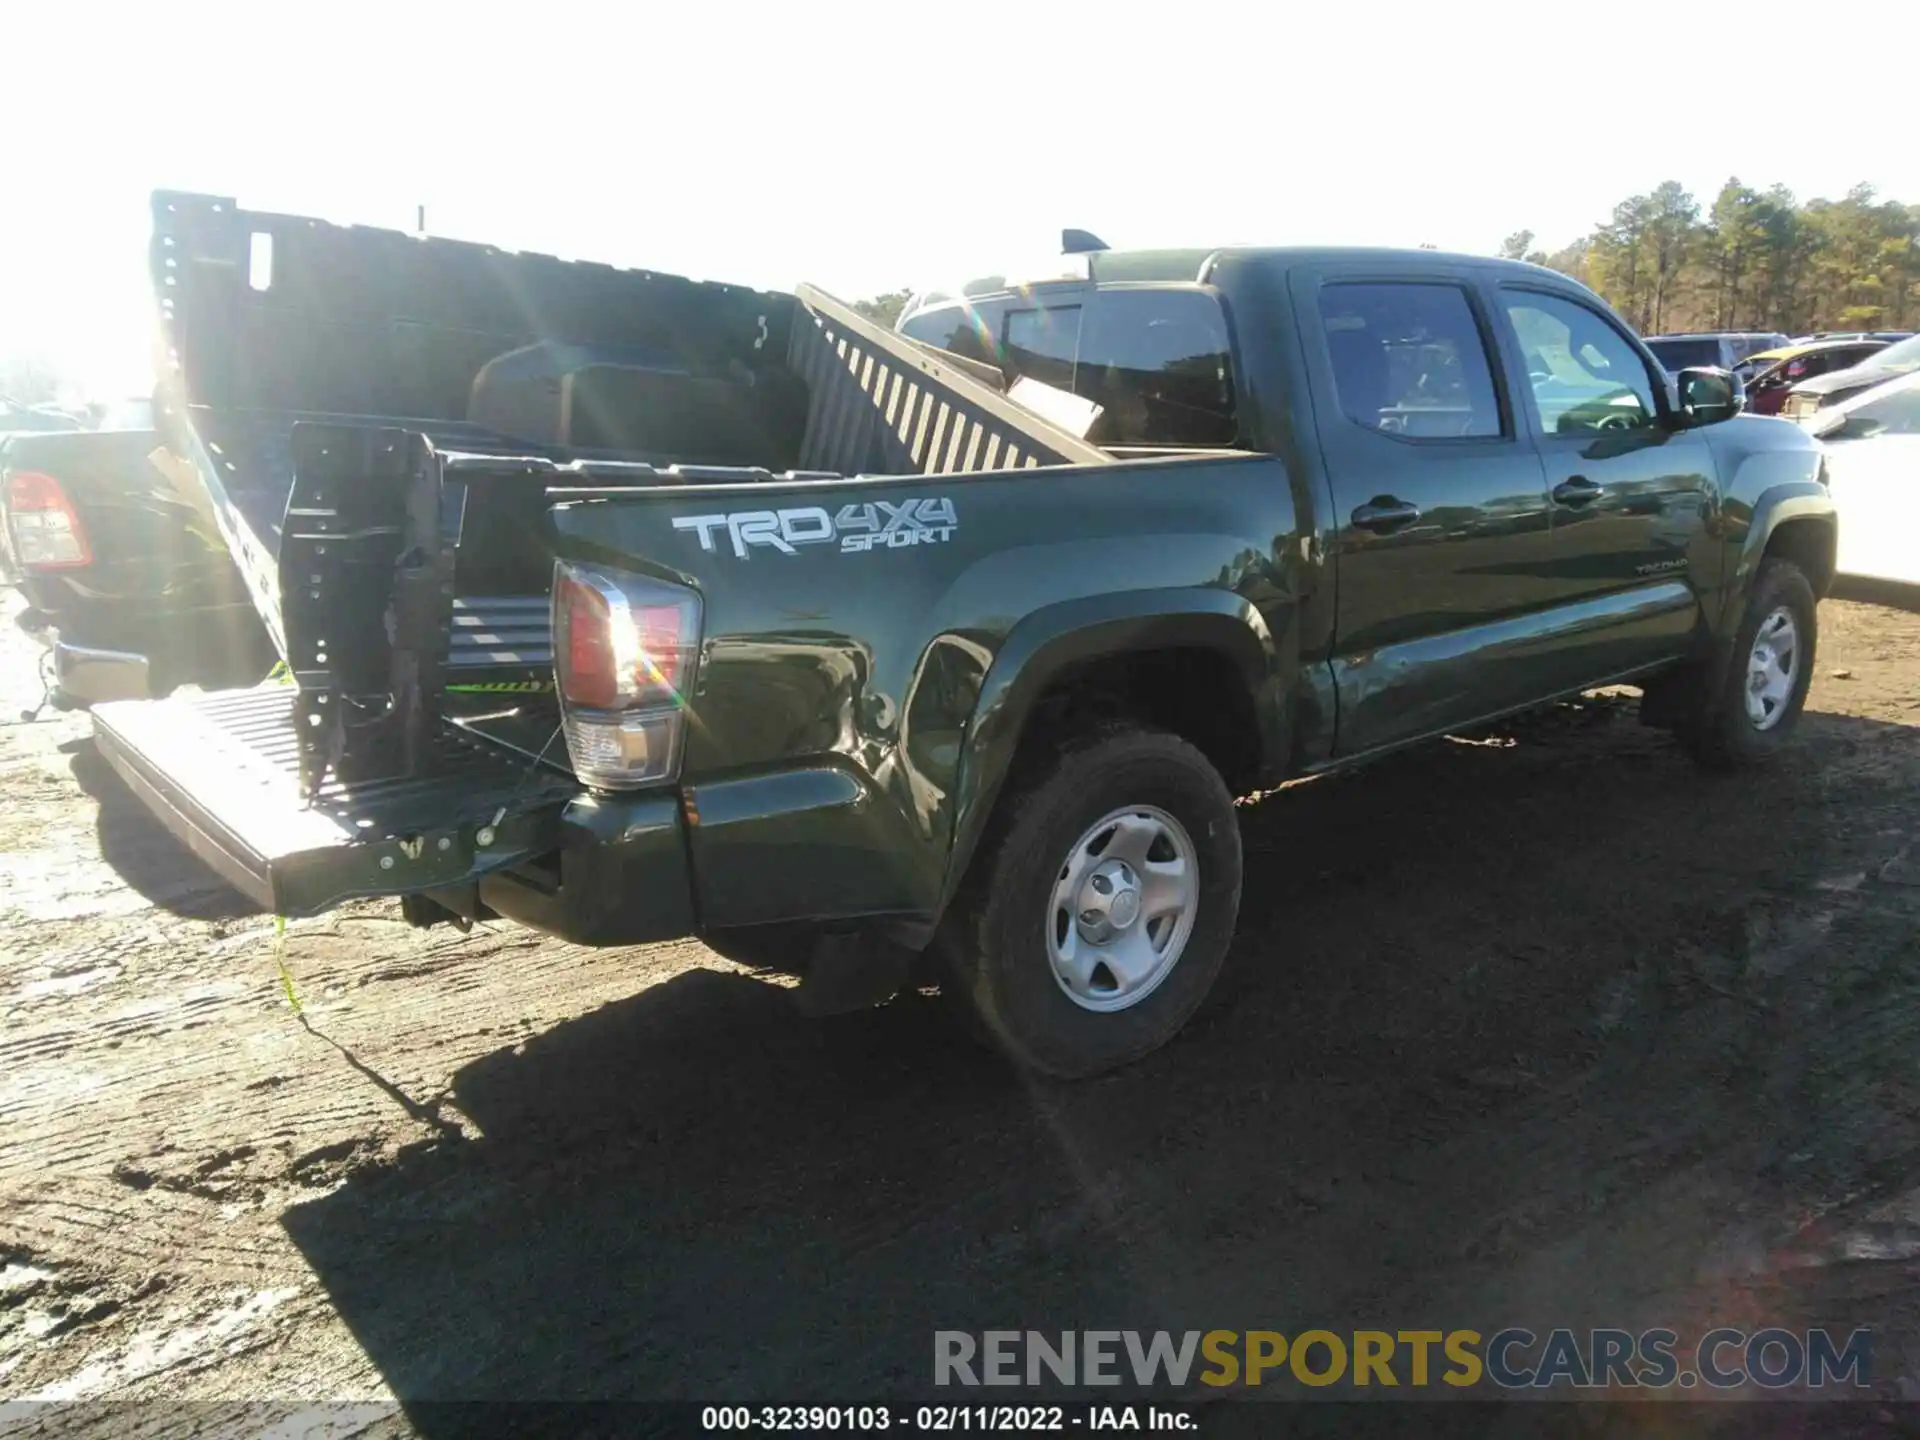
[1680,559,1820,770]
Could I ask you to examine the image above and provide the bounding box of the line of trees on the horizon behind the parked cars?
[1500,177,1920,334]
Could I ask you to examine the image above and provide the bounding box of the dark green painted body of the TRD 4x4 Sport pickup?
[553,250,1832,940]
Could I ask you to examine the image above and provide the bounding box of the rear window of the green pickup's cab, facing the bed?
[900,290,1238,449]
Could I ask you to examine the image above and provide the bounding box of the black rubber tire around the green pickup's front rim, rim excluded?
[1676,559,1820,770]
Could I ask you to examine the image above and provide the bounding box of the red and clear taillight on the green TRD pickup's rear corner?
[553,561,701,789]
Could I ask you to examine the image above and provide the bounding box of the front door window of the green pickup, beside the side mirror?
[1505,290,1659,436]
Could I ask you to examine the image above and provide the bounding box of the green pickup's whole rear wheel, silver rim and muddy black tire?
[939,730,1240,1079]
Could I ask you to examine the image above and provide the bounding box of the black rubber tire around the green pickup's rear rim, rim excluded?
[937,728,1240,1079]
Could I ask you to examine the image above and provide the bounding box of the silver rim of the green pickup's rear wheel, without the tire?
[1046,804,1200,1010]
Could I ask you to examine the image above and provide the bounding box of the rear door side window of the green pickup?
[1319,282,1501,440]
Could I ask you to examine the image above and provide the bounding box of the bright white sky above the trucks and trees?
[0,0,1920,396]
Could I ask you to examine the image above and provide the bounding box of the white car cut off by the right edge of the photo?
[1805,371,1920,586]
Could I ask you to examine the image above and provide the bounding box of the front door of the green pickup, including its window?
[1498,284,1720,689]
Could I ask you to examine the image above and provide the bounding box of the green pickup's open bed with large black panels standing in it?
[151,192,1110,797]
